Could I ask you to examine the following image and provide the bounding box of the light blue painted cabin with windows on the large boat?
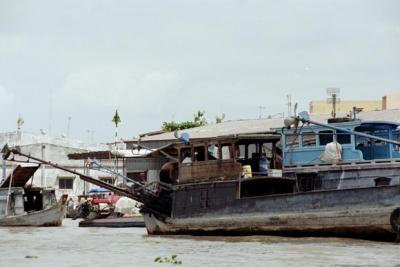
[276,120,400,167]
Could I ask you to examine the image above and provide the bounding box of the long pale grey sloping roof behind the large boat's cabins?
[127,109,400,142]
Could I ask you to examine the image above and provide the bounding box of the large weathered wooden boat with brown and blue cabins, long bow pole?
[3,113,400,240]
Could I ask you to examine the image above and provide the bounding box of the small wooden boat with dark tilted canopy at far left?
[0,165,65,226]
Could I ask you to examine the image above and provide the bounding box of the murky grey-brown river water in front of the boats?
[0,219,400,267]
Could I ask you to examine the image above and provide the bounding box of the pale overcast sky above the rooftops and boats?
[0,0,400,142]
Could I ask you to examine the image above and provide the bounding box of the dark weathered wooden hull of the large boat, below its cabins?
[144,181,400,242]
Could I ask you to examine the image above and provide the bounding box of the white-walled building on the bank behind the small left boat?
[0,131,122,198]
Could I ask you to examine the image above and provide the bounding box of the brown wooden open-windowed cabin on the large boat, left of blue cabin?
[155,133,281,184]
